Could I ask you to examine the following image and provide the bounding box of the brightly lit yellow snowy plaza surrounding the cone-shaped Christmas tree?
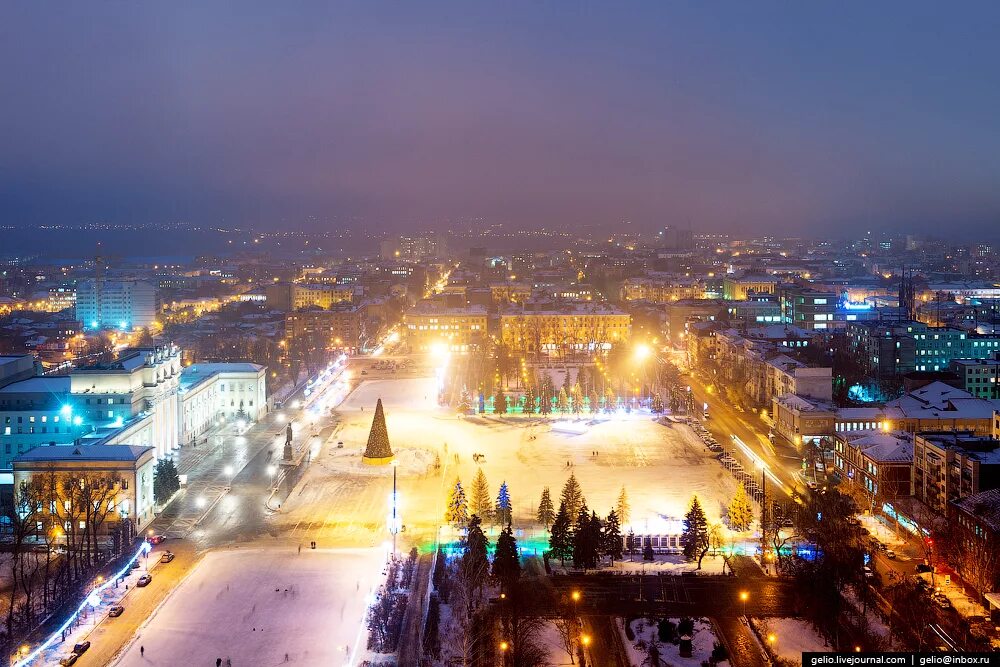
[274,378,736,546]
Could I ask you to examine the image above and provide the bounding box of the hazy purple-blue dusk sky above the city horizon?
[0,0,1000,236]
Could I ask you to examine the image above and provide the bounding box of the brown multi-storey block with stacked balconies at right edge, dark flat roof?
[913,431,1000,516]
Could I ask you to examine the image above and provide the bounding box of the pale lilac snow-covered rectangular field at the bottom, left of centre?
[117,548,385,667]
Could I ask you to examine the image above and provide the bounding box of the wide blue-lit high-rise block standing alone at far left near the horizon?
[76,279,157,331]
